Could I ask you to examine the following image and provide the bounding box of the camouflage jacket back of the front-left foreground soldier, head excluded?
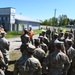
[14,56,41,75]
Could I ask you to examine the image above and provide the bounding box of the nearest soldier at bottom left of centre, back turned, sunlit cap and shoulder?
[14,44,41,75]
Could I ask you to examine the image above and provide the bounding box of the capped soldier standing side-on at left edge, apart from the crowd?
[0,31,10,65]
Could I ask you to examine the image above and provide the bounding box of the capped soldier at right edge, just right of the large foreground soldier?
[66,39,75,75]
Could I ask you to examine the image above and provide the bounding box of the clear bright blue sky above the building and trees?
[0,0,75,20]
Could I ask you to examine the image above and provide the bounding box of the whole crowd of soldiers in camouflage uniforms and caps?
[0,28,75,75]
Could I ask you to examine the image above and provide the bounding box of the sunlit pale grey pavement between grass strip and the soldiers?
[8,35,39,51]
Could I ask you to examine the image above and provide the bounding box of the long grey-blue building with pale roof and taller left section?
[0,7,40,31]
